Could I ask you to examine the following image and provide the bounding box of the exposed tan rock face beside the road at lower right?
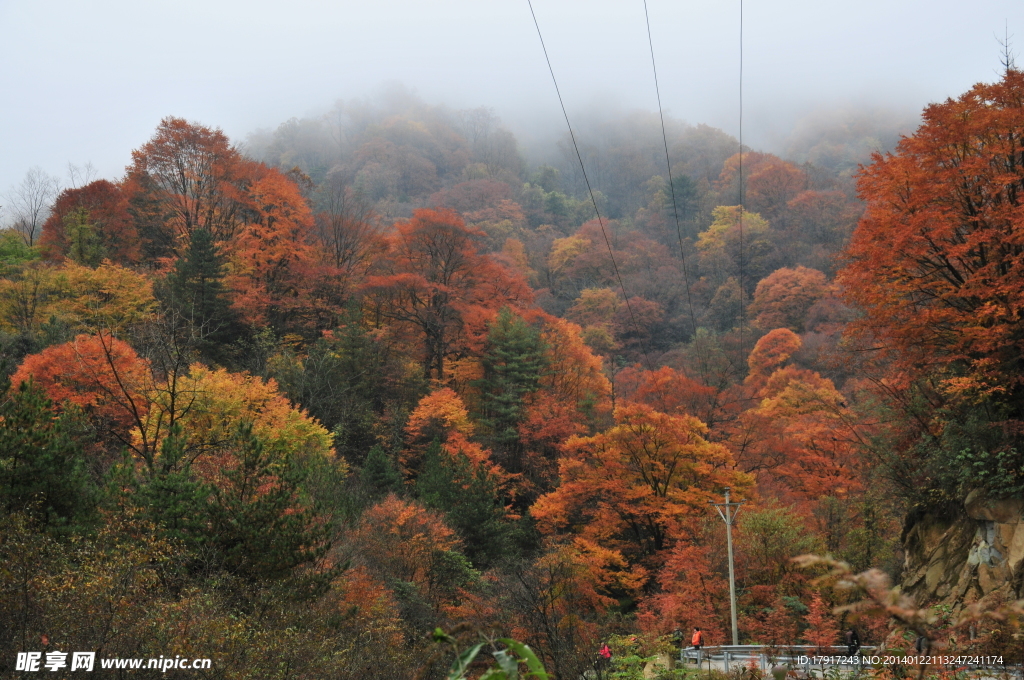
[903,492,1024,609]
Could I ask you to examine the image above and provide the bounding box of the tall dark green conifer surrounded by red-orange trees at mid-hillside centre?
[474,307,547,472]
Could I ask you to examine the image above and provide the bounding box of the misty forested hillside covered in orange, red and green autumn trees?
[6,69,1024,680]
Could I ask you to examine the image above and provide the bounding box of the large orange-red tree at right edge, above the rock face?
[840,69,1024,393]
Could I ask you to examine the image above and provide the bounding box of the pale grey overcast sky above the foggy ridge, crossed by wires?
[0,0,1024,193]
